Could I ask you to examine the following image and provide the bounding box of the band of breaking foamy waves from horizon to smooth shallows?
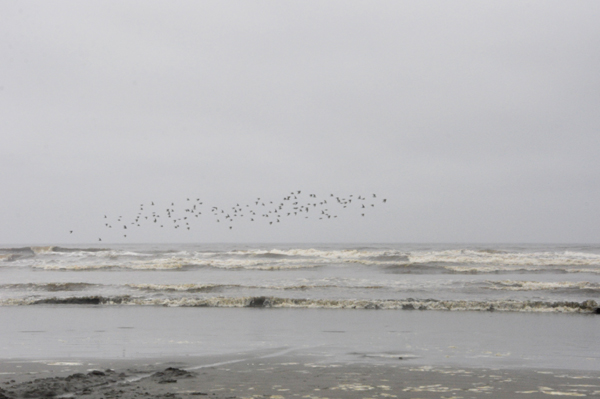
[0,244,600,313]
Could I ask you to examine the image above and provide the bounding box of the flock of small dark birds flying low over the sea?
[70,190,387,241]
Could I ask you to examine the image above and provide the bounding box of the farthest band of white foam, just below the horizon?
[16,247,600,274]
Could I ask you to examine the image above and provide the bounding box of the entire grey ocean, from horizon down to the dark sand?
[0,243,600,370]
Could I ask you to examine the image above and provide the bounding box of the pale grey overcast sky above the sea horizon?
[0,0,600,245]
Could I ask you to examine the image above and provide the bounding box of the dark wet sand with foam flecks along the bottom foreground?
[0,351,600,399]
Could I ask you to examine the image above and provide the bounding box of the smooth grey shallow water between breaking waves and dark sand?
[0,305,600,370]
